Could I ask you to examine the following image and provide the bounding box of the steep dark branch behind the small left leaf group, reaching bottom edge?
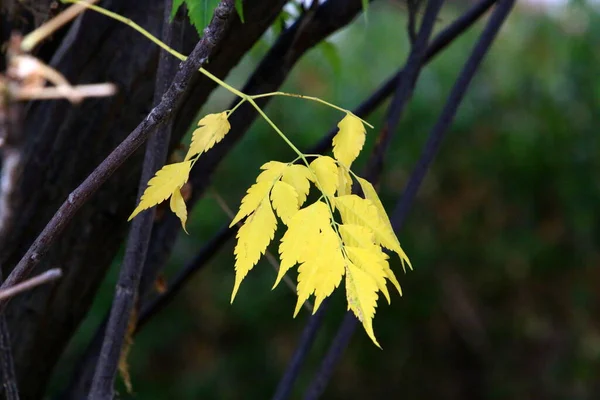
[89,0,183,400]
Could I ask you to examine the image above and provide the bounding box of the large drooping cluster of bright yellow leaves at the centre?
[230,113,410,346]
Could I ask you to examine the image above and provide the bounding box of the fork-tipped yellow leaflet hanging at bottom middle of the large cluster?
[294,226,346,317]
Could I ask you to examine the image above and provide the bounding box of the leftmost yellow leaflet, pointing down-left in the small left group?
[127,161,192,221]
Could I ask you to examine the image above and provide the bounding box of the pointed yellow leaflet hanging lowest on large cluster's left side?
[231,199,277,302]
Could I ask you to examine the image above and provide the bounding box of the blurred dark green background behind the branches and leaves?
[52,1,600,400]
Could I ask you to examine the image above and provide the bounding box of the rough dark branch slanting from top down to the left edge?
[0,0,234,311]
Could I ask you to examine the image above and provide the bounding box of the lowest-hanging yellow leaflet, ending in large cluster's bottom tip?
[346,262,381,348]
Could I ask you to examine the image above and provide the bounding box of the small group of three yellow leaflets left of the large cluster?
[128,112,231,232]
